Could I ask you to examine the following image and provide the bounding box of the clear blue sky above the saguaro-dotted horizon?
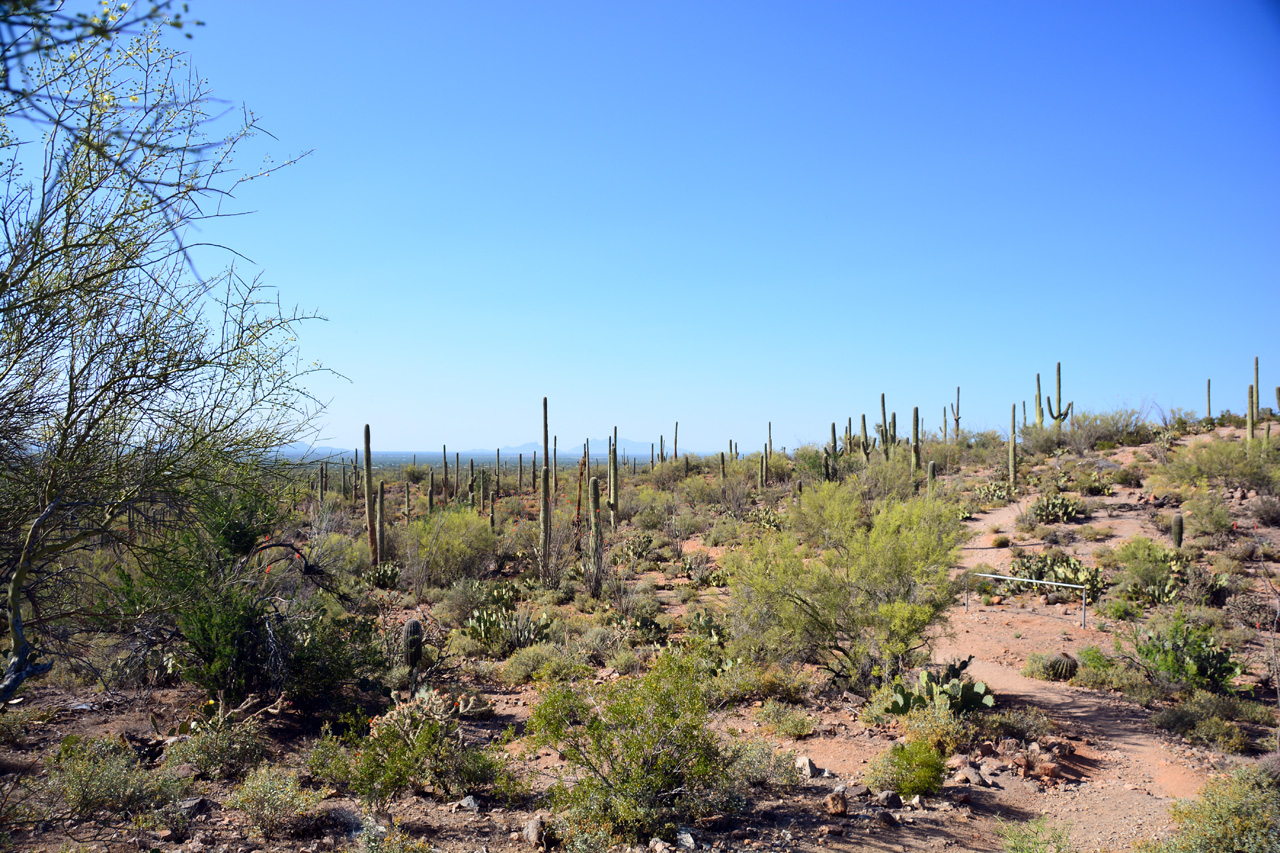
[172,0,1280,451]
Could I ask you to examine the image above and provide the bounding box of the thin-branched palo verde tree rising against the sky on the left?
[0,18,315,699]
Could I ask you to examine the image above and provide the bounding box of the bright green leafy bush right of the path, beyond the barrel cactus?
[1128,607,1240,690]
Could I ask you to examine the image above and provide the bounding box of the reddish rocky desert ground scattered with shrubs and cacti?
[0,397,1280,853]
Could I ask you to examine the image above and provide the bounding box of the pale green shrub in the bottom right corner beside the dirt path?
[1138,766,1280,853]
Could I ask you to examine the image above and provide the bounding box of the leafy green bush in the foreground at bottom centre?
[529,652,740,849]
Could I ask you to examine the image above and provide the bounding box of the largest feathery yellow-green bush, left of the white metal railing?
[722,491,965,684]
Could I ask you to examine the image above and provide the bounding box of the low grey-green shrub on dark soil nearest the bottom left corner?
[45,735,183,820]
